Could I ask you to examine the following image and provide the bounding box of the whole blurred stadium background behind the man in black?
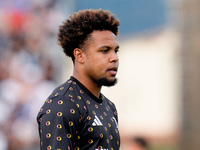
[0,0,200,150]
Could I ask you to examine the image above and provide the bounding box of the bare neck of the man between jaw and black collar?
[73,70,101,98]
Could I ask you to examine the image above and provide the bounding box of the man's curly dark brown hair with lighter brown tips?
[58,9,120,61]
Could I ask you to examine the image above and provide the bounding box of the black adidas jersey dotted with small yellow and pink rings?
[37,77,120,150]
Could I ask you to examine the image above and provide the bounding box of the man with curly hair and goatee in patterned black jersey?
[37,9,120,150]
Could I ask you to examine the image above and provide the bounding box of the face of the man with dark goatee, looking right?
[84,31,119,86]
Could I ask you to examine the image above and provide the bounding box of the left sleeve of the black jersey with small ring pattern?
[38,96,81,150]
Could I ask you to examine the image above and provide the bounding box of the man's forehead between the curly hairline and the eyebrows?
[88,30,118,47]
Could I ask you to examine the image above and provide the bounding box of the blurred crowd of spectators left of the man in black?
[0,0,65,150]
